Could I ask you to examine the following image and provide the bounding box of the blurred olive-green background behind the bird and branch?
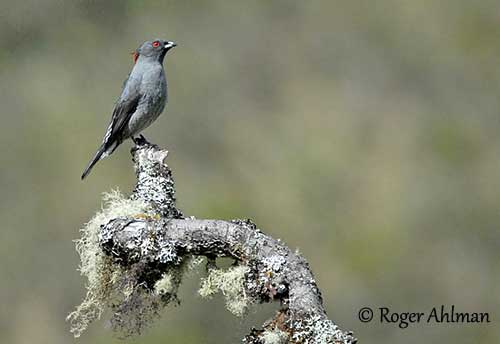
[0,0,500,344]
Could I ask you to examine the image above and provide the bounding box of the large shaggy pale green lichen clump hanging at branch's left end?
[67,191,202,337]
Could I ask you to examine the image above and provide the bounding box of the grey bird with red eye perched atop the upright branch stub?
[81,39,177,180]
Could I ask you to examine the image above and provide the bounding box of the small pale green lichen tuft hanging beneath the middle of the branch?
[198,265,251,316]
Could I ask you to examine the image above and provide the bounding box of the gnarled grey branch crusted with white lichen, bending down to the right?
[71,144,356,344]
